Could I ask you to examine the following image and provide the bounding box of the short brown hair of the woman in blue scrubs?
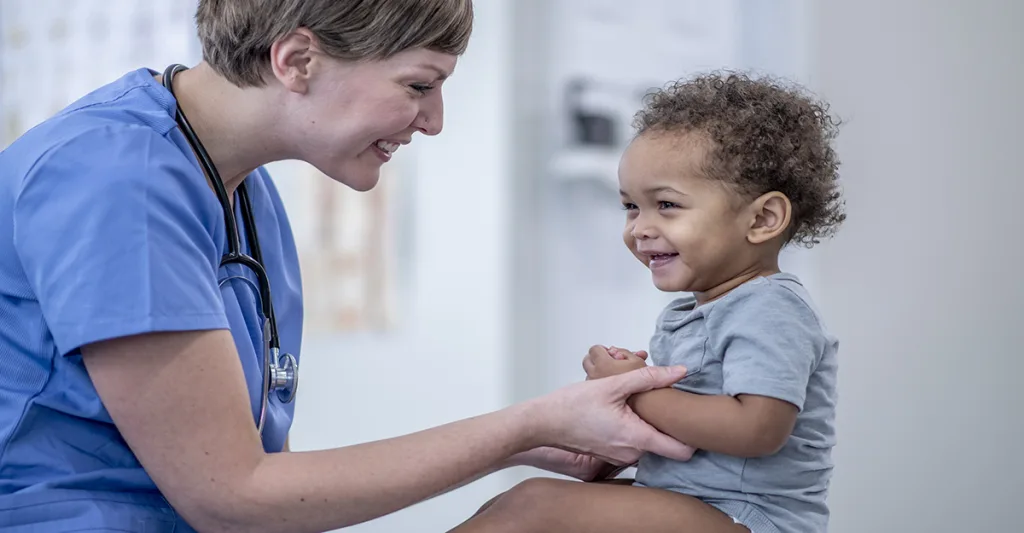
[196,0,473,87]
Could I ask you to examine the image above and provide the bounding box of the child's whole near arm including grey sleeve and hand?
[584,281,827,457]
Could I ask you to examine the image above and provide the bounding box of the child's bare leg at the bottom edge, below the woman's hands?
[450,478,749,533]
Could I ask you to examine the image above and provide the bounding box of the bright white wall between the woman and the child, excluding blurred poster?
[292,0,514,533]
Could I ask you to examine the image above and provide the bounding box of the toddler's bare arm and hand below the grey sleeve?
[585,347,798,457]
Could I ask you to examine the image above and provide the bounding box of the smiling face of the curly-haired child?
[618,130,750,293]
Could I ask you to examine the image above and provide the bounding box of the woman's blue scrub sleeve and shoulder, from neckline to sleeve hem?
[0,70,234,354]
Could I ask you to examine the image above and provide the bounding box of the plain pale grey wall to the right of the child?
[810,0,1024,533]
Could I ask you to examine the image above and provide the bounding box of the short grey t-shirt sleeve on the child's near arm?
[709,281,825,410]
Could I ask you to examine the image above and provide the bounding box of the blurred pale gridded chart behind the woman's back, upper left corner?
[0,0,200,146]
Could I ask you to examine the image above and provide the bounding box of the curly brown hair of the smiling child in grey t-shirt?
[634,72,846,248]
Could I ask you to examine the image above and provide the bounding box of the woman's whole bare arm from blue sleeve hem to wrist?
[82,329,540,533]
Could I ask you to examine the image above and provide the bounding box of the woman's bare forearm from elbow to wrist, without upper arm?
[222,403,538,532]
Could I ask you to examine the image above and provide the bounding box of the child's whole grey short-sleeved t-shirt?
[636,273,839,533]
